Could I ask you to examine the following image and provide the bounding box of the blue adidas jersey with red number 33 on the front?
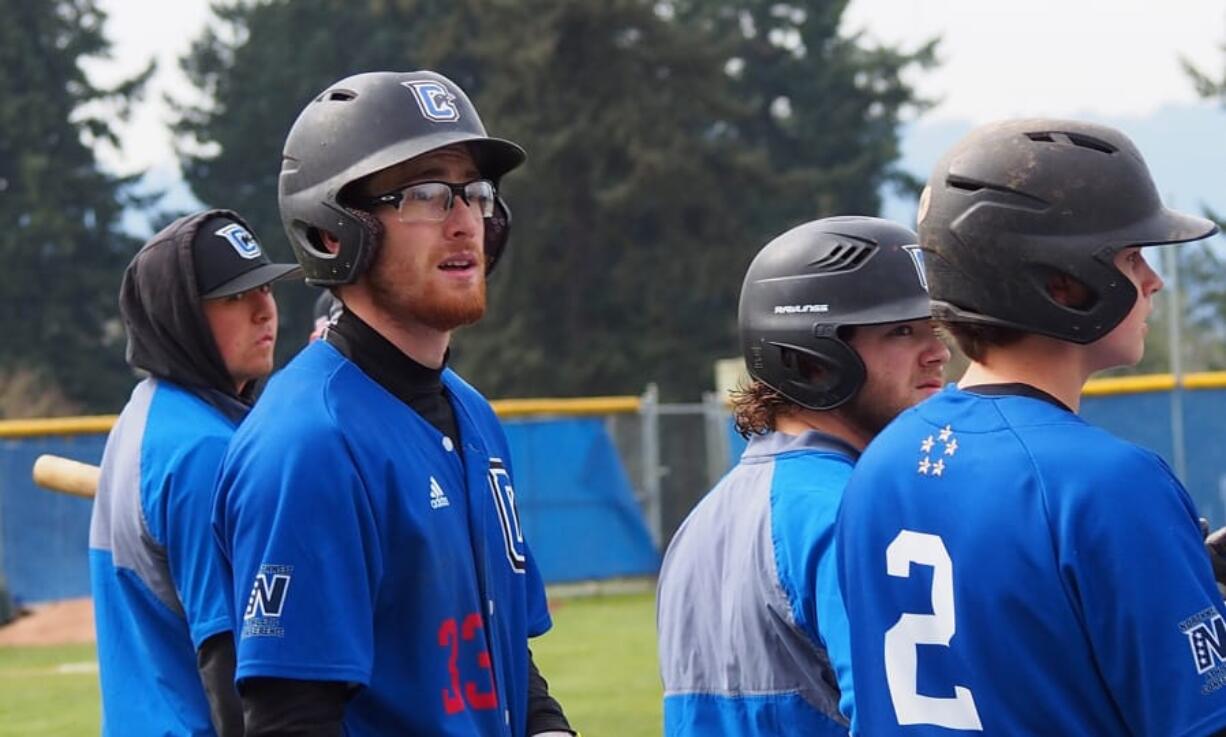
[213,341,549,737]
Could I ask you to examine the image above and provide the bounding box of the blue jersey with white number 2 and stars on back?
[837,388,1226,737]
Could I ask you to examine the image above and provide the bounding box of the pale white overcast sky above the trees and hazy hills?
[89,0,1226,190]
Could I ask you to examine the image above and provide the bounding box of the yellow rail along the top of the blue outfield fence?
[7,372,1226,438]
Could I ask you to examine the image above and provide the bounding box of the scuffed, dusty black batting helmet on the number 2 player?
[918,120,1217,343]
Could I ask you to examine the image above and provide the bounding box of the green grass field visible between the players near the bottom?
[0,594,661,737]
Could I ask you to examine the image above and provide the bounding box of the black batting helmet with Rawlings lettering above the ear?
[738,212,931,410]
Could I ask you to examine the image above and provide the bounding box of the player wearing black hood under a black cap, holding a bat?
[89,210,299,737]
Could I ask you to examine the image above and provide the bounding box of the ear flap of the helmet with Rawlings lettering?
[769,336,867,411]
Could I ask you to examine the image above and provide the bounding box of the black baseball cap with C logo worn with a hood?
[191,215,302,299]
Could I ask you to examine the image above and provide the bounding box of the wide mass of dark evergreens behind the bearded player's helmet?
[179,0,932,397]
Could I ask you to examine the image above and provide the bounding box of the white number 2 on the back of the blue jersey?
[885,530,983,731]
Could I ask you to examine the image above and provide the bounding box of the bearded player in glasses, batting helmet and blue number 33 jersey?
[215,71,571,737]
